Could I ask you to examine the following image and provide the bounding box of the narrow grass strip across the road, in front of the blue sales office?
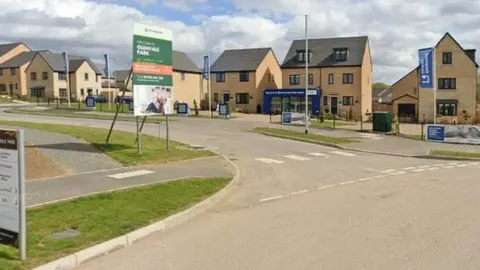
[253,127,358,145]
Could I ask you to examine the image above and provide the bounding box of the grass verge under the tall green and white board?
[0,121,215,165]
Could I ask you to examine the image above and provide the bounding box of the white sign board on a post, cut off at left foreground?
[0,129,27,260]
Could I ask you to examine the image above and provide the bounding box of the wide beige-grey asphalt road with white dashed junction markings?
[0,110,480,270]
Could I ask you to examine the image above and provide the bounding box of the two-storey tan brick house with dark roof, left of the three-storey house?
[210,48,282,113]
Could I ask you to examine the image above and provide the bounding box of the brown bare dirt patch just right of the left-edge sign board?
[25,145,69,180]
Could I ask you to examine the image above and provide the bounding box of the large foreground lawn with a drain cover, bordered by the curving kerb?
[0,178,229,270]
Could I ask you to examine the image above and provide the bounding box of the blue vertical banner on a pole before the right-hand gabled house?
[418,48,437,124]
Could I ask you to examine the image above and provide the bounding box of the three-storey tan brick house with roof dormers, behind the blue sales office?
[281,36,373,121]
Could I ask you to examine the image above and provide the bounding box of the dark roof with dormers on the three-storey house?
[282,36,368,68]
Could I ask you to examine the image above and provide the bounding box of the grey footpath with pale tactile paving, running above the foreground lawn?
[26,156,234,207]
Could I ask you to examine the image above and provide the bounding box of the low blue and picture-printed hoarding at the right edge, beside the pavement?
[425,125,480,144]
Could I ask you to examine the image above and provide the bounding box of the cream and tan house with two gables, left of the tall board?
[25,52,102,100]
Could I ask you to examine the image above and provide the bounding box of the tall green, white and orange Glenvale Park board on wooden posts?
[132,23,173,116]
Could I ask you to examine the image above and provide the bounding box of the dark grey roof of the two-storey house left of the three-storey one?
[210,48,271,72]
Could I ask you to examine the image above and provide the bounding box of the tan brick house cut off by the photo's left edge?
[0,43,31,95]
